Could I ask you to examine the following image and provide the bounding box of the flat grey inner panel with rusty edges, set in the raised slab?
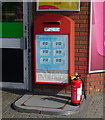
[24,95,68,109]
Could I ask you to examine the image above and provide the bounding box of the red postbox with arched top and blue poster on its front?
[34,13,75,85]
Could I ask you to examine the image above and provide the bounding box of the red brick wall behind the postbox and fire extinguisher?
[33,2,105,94]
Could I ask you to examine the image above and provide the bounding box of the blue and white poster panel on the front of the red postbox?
[36,35,68,83]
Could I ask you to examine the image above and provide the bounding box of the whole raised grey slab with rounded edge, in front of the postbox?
[12,94,79,115]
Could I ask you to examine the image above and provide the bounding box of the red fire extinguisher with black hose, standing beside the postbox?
[71,73,86,106]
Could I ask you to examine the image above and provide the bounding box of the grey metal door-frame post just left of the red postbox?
[23,2,32,91]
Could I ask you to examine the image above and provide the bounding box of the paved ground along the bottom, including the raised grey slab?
[0,89,105,120]
